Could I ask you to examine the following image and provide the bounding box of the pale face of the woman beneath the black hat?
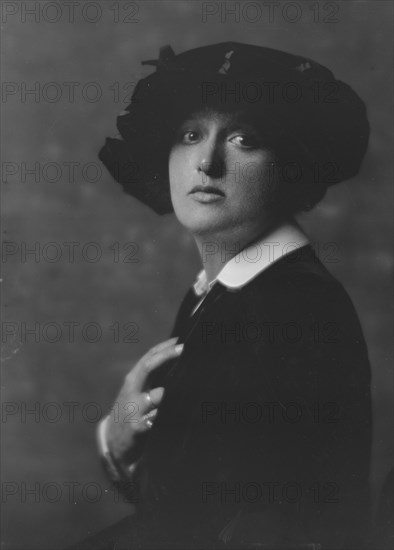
[169,110,277,240]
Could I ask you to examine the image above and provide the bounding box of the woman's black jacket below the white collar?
[69,246,371,549]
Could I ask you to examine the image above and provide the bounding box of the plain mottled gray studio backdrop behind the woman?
[1,0,392,549]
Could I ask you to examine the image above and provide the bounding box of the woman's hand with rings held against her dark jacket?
[106,338,183,472]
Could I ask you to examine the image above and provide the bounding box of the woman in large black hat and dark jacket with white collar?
[72,42,371,549]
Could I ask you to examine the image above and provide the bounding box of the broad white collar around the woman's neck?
[193,220,309,296]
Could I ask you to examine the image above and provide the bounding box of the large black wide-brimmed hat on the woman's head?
[99,42,369,214]
